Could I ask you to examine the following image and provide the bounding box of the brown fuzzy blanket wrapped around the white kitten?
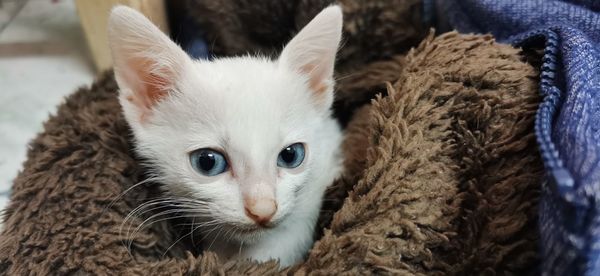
[0,1,543,275]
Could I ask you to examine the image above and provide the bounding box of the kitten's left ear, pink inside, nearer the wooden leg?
[108,6,191,122]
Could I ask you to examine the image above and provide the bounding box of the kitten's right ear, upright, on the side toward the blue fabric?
[279,6,342,105]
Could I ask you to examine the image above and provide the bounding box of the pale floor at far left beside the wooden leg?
[0,0,94,210]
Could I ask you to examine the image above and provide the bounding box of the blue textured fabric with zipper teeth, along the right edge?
[432,0,600,275]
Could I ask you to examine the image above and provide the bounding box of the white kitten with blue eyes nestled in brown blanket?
[109,6,342,266]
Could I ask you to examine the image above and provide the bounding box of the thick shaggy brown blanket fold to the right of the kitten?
[314,33,543,275]
